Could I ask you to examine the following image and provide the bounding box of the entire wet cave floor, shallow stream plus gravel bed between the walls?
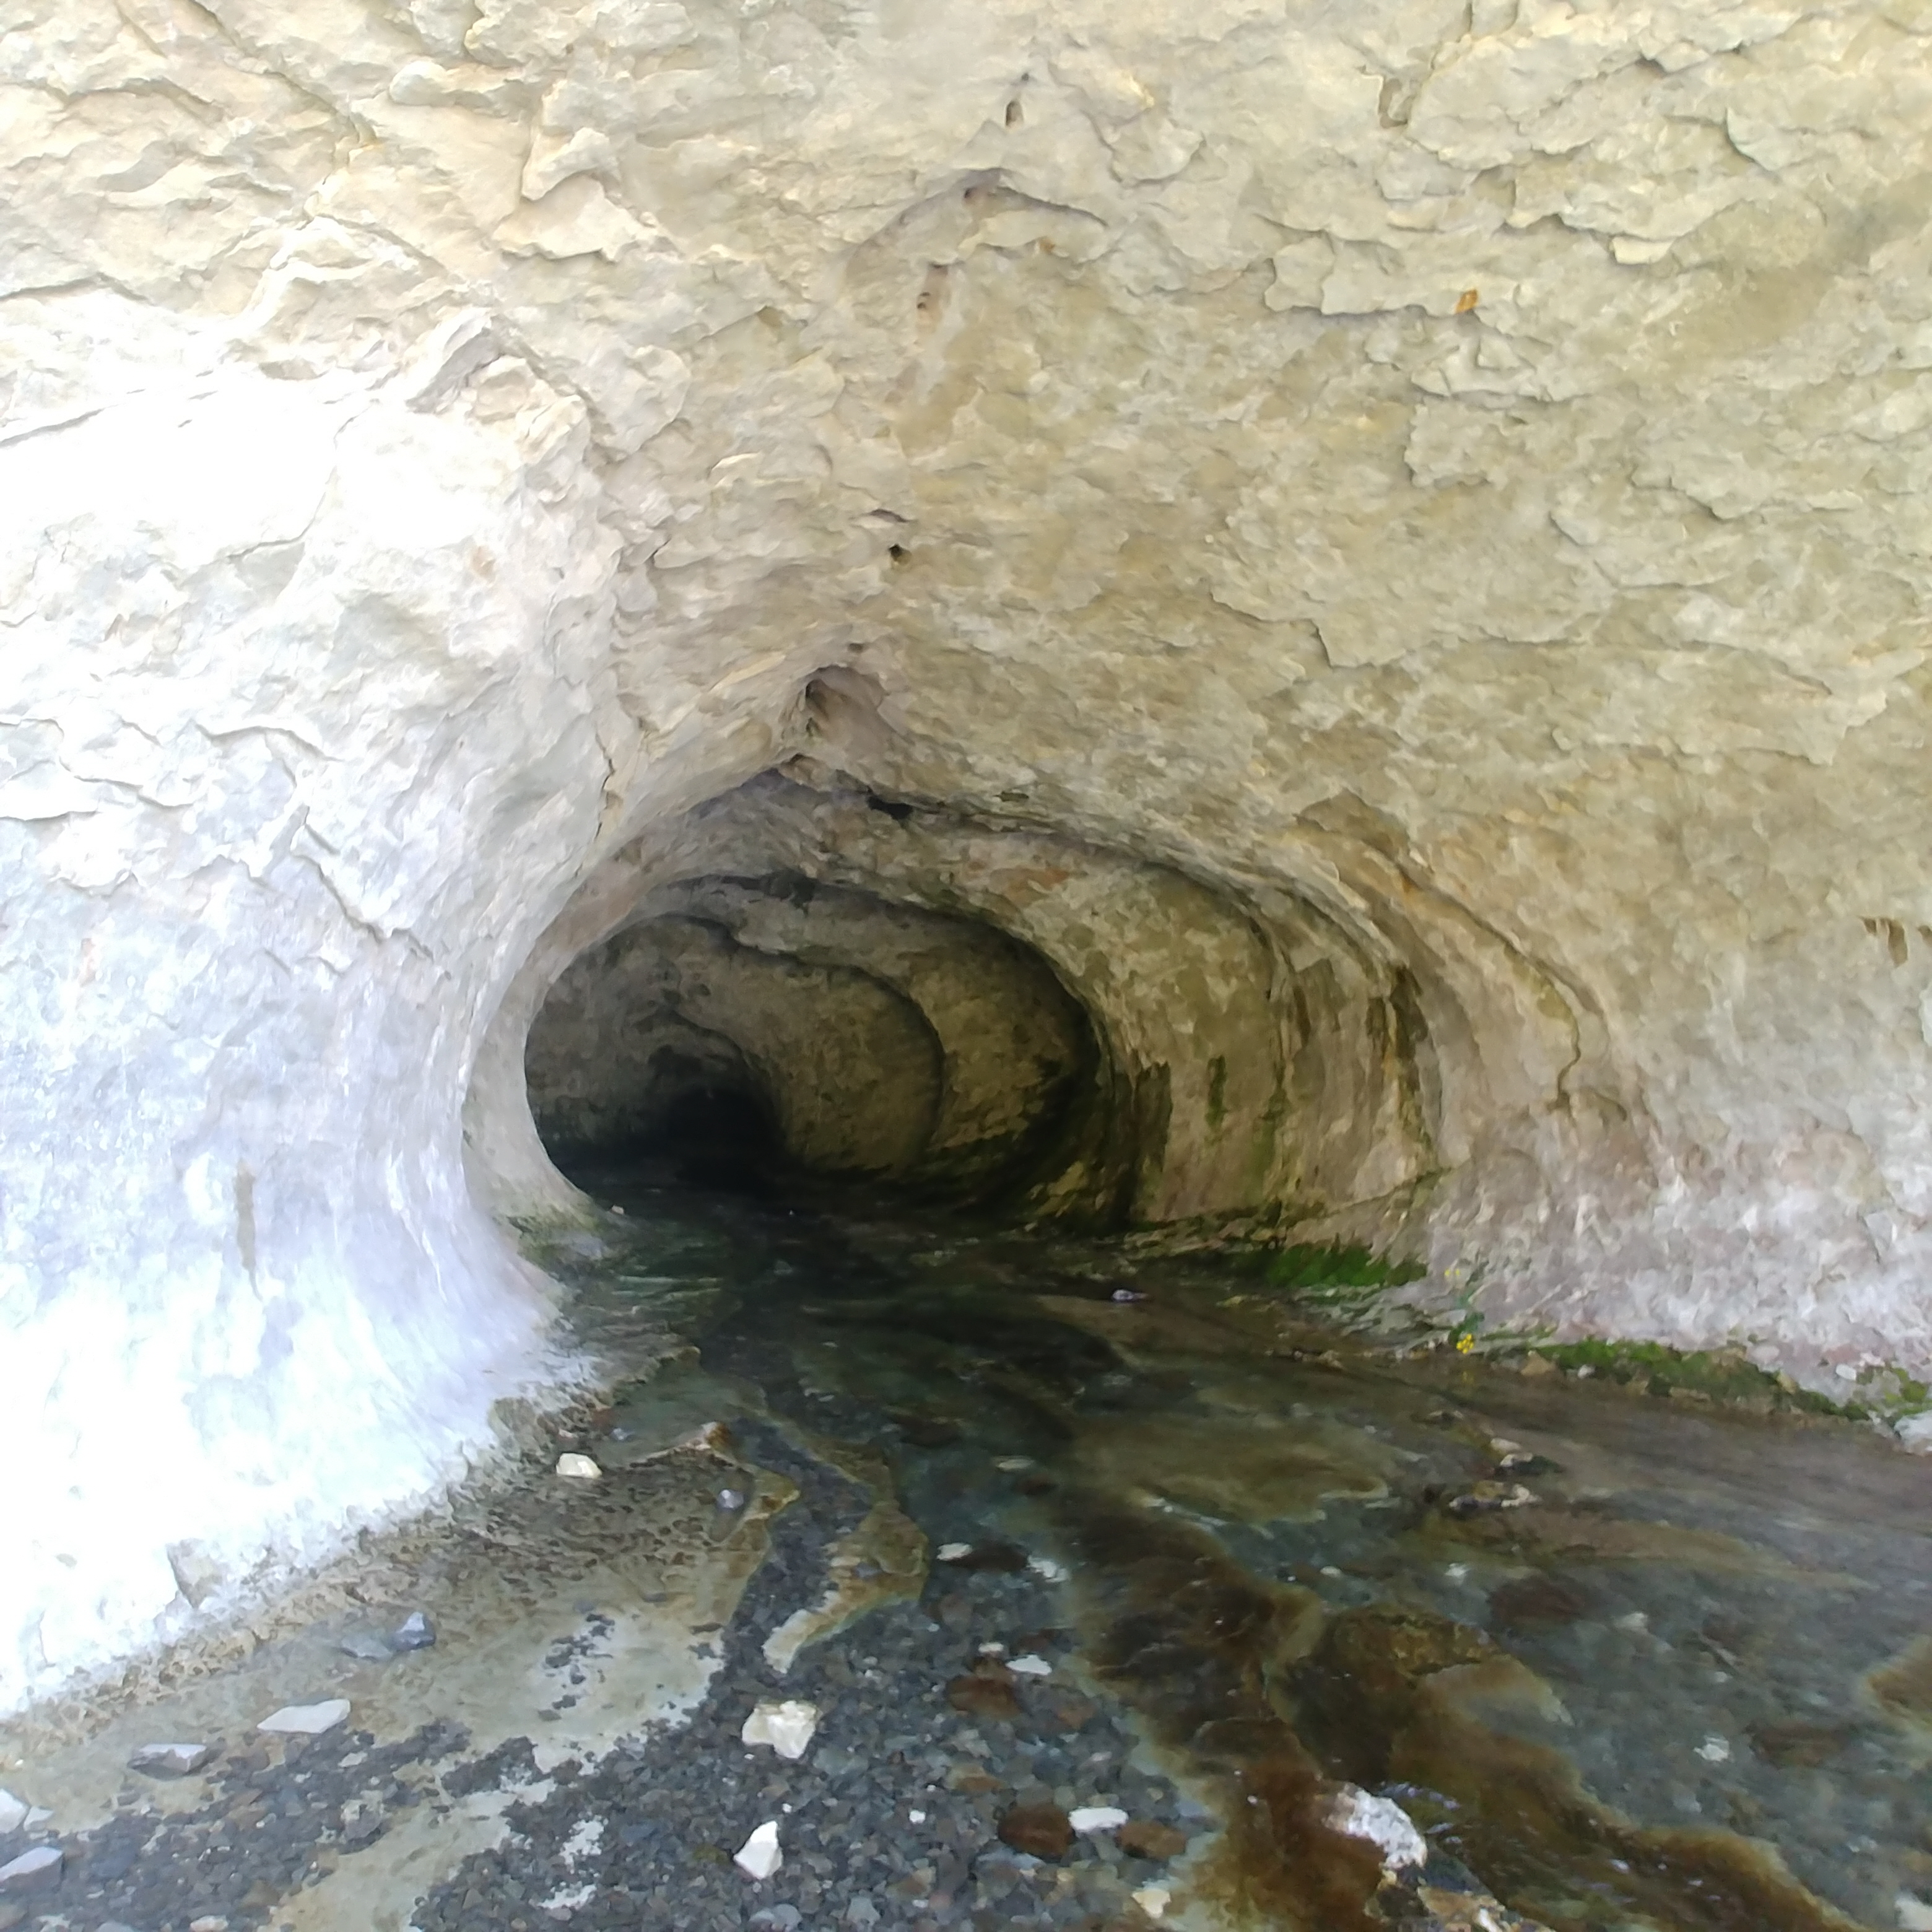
[0,1171,1932,1932]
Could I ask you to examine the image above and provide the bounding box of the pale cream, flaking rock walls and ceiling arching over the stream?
[0,0,1932,1706]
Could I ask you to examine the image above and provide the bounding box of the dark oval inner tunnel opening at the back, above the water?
[526,875,1105,1208]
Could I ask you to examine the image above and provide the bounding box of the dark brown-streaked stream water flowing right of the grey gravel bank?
[564,1175,1932,1932]
